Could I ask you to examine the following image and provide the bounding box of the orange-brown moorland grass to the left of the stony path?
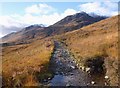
[2,39,54,87]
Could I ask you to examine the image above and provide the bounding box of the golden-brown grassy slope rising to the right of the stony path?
[58,16,118,86]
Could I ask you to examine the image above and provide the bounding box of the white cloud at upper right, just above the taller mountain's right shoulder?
[79,0,118,16]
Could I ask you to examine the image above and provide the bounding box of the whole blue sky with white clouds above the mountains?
[0,0,118,37]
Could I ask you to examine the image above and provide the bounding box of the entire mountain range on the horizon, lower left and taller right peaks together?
[2,12,106,43]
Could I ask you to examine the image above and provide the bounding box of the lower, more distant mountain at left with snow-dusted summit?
[2,24,45,43]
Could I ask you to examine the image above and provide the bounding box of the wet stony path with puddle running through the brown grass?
[49,42,90,86]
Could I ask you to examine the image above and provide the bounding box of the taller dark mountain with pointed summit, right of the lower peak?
[48,12,107,35]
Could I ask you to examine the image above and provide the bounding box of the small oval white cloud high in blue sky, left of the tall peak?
[25,4,55,14]
